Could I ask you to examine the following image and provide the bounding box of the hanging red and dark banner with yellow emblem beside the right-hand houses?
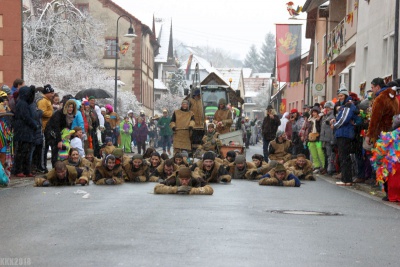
[276,24,301,82]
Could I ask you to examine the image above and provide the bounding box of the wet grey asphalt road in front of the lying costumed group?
[0,146,400,266]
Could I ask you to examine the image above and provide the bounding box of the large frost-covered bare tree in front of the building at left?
[24,0,140,114]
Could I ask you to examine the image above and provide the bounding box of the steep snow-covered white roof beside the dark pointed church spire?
[154,18,172,62]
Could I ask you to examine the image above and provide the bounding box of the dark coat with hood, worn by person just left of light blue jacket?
[44,99,77,144]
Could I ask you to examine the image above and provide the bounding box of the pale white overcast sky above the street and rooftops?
[113,0,310,59]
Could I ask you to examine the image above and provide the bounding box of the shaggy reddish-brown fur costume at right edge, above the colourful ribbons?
[367,88,399,142]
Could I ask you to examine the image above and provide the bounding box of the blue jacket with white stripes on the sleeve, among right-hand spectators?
[334,96,358,139]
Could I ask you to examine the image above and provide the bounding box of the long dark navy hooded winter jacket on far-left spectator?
[14,86,41,143]
